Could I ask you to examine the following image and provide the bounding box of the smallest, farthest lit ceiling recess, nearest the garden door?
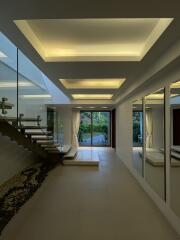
[72,94,113,100]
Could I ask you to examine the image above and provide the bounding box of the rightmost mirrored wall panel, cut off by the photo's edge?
[170,81,180,217]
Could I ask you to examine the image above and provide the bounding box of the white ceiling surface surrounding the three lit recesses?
[0,0,180,105]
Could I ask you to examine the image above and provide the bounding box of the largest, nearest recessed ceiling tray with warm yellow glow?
[15,18,173,62]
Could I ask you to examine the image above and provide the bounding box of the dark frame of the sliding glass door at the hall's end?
[79,110,112,147]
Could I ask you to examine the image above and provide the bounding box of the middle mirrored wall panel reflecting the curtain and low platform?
[145,89,165,199]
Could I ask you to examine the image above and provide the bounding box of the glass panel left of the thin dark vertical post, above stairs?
[0,32,17,118]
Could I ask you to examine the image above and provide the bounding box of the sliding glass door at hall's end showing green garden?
[78,111,111,146]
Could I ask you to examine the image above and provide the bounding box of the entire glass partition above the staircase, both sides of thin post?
[0,32,56,137]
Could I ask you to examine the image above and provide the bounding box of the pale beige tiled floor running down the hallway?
[0,149,180,240]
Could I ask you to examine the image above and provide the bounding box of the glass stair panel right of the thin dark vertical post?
[18,51,52,126]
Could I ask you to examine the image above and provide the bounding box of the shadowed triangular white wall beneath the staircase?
[0,134,37,185]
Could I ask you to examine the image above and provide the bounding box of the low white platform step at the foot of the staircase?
[63,147,103,166]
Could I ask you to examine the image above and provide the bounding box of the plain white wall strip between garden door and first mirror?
[116,102,132,167]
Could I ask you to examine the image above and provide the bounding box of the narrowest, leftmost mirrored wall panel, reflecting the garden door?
[132,99,143,176]
